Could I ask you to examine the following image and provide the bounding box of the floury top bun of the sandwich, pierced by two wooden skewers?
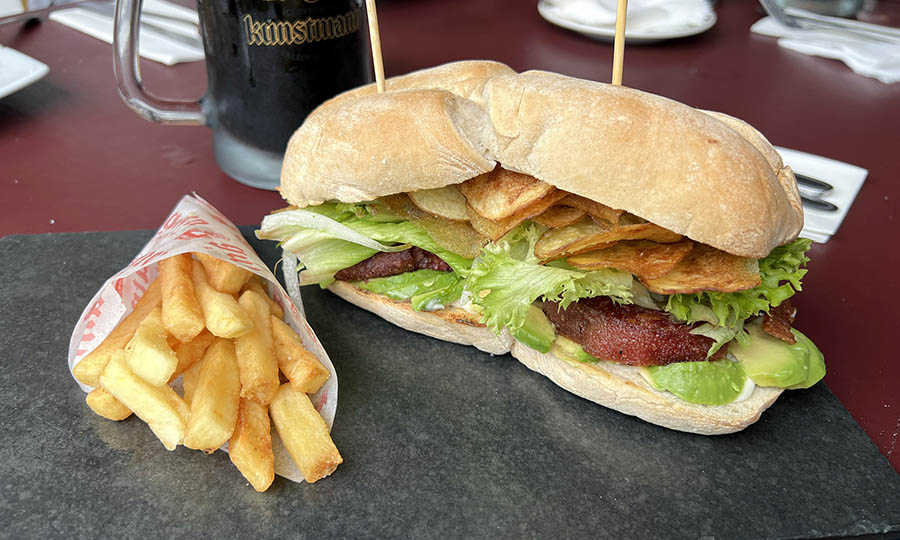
[281,61,803,258]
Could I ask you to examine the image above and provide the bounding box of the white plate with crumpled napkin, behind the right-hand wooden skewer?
[545,0,713,34]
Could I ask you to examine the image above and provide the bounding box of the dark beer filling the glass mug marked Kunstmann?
[198,0,372,155]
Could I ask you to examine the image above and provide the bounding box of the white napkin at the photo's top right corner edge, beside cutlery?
[750,17,900,84]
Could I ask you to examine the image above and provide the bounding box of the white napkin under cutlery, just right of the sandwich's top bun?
[775,146,869,244]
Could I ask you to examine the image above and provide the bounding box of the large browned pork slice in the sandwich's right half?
[544,296,725,366]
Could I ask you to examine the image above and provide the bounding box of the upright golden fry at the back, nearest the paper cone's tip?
[159,253,203,341]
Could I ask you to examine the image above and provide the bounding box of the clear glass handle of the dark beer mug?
[113,0,206,125]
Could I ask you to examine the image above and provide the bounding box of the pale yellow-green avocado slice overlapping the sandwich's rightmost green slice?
[728,324,810,388]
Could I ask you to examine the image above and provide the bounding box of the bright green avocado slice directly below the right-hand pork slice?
[643,359,747,405]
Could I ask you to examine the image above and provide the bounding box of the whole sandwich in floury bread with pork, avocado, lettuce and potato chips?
[257,61,825,434]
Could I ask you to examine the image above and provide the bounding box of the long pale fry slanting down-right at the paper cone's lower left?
[100,351,188,450]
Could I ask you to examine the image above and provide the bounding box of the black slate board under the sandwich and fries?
[0,228,900,539]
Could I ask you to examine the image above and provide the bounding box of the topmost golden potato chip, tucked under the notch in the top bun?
[459,167,554,219]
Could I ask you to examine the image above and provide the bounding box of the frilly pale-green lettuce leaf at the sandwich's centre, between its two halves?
[465,223,632,332]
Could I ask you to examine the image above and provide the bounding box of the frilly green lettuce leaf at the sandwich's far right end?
[665,238,812,354]
